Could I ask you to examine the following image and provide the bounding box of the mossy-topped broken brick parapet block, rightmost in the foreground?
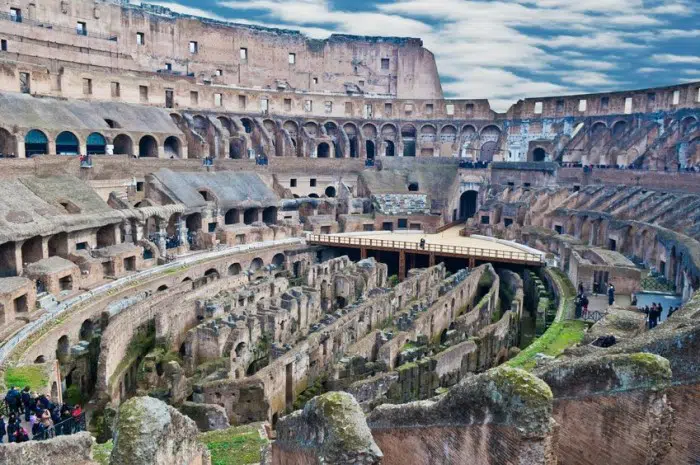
[536,349,672,465]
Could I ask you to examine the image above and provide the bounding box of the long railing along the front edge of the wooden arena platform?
[307,234,544,264]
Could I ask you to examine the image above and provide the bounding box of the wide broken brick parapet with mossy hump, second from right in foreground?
[368,366,556,465]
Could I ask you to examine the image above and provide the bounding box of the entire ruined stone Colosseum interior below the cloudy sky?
[0,0,700,465]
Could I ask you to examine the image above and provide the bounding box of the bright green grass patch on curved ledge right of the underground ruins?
[508,320,588,370]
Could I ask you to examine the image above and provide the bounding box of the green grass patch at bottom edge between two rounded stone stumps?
[198,424,268,465]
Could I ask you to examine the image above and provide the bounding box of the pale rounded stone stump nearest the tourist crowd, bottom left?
[109,397,209,465]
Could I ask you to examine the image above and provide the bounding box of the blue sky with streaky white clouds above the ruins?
[147,0,700,110]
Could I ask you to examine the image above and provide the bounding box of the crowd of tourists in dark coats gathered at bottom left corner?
[0,386,85,443]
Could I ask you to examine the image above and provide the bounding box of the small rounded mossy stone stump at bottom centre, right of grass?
[272,392,382,465]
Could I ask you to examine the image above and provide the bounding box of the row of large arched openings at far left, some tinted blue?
[0,128,182,158]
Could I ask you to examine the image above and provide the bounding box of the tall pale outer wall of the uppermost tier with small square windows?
[0,0,442,98]
